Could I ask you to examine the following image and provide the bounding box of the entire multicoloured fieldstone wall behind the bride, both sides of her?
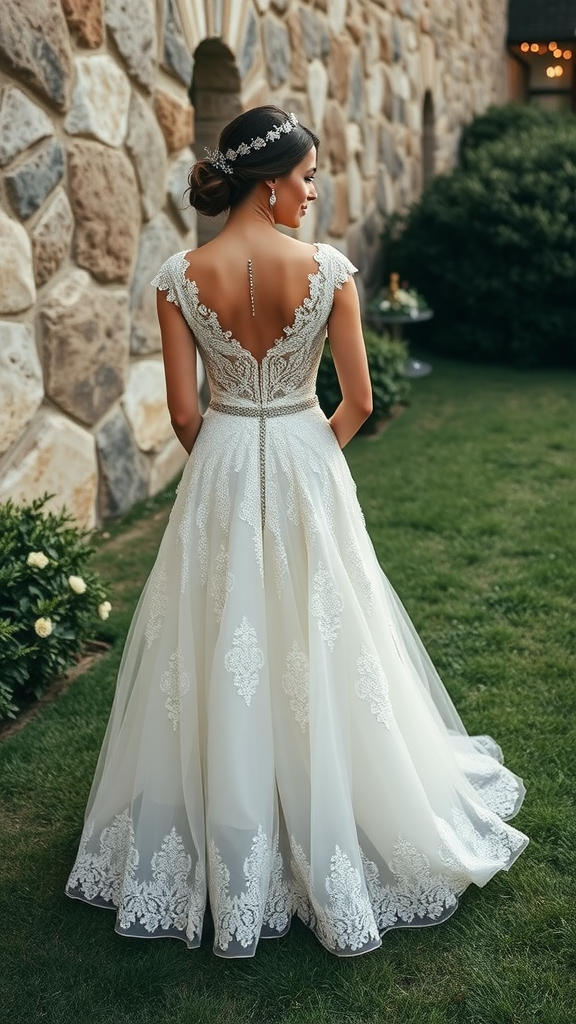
[0,0,506,526]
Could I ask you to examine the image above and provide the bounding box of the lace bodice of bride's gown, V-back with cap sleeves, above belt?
[152,243,357,407]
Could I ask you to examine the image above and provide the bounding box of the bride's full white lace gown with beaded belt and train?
[67,245,528,957]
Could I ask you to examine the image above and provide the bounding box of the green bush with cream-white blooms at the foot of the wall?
[0,495,111,719]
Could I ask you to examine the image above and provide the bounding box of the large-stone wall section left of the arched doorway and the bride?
[0,0,196,526]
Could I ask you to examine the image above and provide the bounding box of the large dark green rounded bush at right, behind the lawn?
[385,108,576,367]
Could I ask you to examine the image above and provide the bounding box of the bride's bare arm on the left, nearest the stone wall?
[156,291,202,455]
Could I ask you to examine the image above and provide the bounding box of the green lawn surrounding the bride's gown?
[0,359,576,1024]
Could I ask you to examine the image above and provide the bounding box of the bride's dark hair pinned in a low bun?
[184,106,320,217]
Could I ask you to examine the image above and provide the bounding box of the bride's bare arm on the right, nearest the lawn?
[328,278,372,447]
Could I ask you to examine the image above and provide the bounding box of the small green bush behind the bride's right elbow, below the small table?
[317,330,410,433]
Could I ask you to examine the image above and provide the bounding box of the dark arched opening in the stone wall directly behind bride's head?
[190,39,242,246]
